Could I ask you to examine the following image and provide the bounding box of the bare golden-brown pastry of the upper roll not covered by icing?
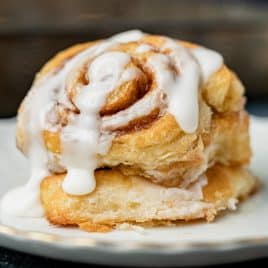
[17,35,251,186]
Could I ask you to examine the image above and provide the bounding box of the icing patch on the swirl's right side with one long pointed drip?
[149,39,223,133]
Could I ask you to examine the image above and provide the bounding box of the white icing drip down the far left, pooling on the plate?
[1,75,57,217]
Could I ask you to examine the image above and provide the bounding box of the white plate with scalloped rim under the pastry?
[0,118,268,267]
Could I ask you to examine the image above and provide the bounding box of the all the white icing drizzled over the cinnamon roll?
[1,30,222,216]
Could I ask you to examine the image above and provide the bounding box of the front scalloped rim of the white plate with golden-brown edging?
[0,224,268,253]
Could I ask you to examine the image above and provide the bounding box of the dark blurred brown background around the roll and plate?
[0,0,268,268]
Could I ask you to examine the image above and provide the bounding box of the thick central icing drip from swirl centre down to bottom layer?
[62,52,132,195]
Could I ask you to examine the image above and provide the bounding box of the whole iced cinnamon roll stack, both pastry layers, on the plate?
[2,28,257,231]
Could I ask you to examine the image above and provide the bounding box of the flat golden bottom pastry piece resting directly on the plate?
[41,165,258,232]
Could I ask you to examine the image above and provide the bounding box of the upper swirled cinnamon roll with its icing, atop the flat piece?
[2,31,258,228]
